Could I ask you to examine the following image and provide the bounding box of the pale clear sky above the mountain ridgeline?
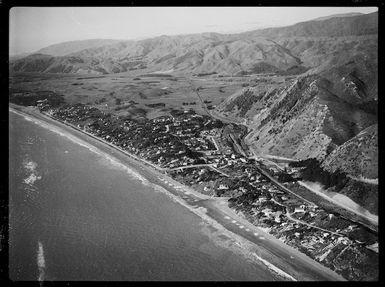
[9,7,378,55]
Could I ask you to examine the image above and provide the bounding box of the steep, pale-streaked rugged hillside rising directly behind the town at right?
[217,75,377,160]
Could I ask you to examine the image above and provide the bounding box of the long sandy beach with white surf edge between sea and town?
[10,105,344,281]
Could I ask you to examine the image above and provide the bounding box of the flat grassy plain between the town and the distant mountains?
[10,72,252,118]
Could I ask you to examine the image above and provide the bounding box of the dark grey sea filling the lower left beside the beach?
[9,113,279,281]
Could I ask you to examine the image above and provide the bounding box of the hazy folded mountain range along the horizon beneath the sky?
[10,13,378,74]
